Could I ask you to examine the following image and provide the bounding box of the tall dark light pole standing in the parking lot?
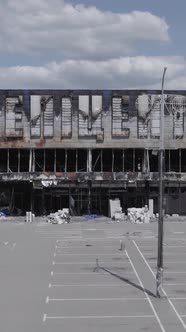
[156,67,167,297]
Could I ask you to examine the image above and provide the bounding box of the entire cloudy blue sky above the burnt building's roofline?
[0,0,186,89]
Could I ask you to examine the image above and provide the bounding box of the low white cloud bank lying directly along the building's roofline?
[0,56,186,89]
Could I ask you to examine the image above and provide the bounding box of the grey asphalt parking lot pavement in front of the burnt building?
[0,218,186,332]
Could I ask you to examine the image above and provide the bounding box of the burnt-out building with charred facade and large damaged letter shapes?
[0,90,186,215]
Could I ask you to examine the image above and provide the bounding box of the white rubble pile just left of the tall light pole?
[127,205,150,224]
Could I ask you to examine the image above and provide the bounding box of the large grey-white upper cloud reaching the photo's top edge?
[0,0,169,60]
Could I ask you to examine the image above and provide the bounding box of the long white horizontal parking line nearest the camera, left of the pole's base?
[43,314,154,322]
